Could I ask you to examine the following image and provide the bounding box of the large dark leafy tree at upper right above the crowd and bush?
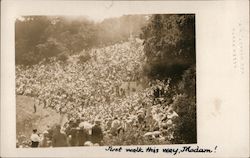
[141,14,195,80]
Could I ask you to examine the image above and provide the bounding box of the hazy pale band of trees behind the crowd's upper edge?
[15,15,146,65]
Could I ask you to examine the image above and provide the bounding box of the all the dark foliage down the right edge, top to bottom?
[141,14,197,143]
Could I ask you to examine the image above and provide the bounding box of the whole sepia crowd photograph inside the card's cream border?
[15,14,197,148]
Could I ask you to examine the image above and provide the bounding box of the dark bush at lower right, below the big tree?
[173,67,197,143]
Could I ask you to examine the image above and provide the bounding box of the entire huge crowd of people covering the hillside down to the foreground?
[16,40,178,147]
